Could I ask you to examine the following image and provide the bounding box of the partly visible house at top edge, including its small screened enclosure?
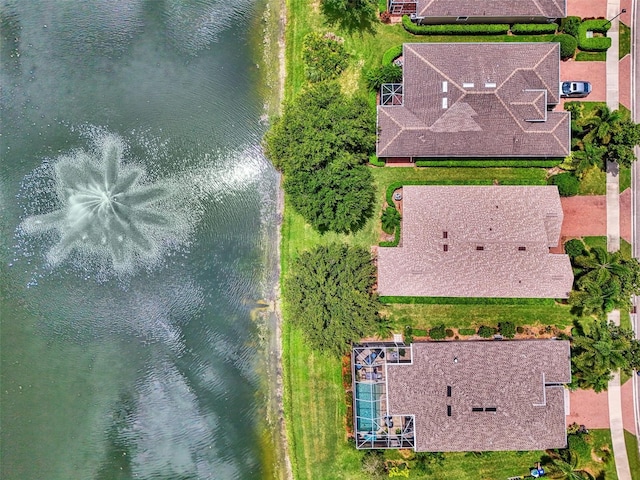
[400,0,567,24]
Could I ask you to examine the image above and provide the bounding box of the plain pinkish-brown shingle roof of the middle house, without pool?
[378,186,573,298]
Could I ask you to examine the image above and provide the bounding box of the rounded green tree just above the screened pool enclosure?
[285,244,380,356]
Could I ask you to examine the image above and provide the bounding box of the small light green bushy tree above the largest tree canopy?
[302,32,349,82]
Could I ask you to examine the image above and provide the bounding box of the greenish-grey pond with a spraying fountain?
[0,0,278,480]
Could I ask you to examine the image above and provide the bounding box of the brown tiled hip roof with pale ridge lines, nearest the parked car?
[376,43,571,157]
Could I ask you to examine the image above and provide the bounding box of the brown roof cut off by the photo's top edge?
[417,0,567,18]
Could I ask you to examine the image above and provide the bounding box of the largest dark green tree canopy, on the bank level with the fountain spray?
[266,82,375,233]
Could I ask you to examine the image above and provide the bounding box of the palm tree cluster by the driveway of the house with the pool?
[571,320,640,392]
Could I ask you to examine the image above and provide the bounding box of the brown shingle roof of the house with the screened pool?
[387,340,571,452]
